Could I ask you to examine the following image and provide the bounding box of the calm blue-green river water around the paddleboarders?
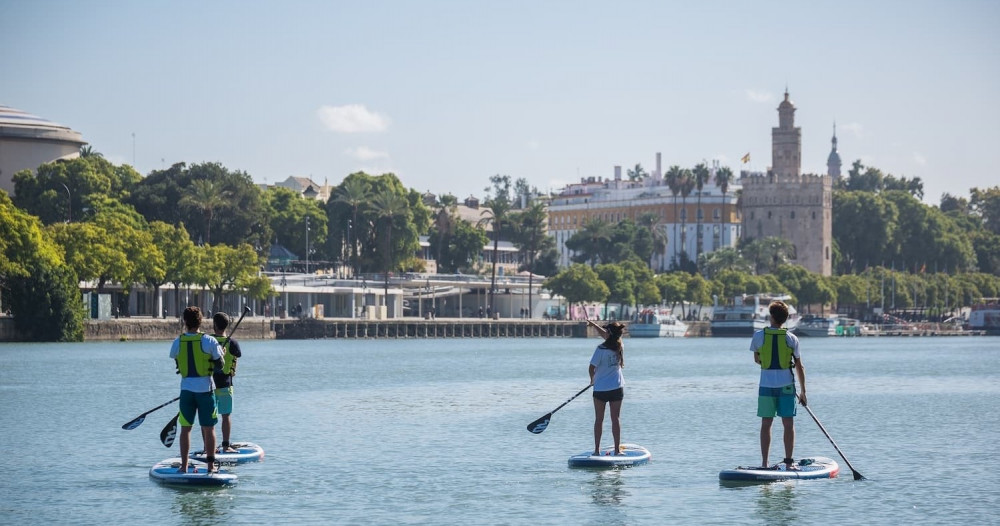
[0,337,1000,525]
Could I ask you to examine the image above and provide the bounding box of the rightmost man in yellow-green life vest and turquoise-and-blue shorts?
[750,301,806,469]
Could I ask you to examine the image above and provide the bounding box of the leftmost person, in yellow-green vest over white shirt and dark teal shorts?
[170,306,224,473]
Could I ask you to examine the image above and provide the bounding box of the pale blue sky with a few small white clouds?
[0,0,1000,204]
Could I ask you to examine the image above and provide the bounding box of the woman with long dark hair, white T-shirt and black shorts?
[587,320,625,455]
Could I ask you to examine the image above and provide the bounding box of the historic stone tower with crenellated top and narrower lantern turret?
[740,90,833,276]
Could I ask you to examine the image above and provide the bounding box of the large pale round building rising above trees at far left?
[0,105,87,194]
